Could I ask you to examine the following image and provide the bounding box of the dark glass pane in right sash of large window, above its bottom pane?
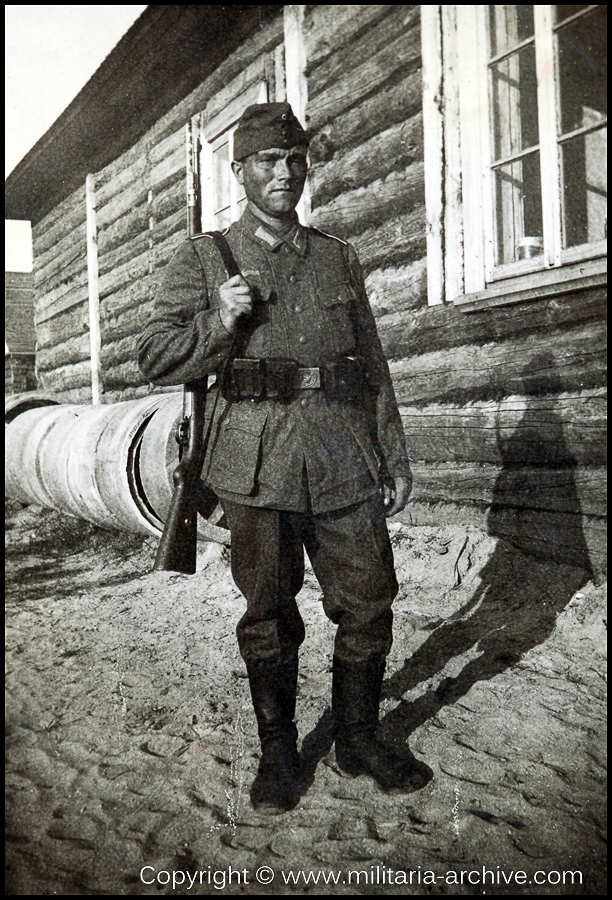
[557,9,608,134]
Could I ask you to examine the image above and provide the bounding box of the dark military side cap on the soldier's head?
[234,103,308,161]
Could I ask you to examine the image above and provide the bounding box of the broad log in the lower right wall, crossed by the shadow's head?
[400,388,607,466]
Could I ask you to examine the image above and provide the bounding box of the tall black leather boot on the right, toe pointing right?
[332,657,429,792]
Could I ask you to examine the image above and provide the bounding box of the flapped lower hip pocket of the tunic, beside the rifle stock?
[206,401,268,494]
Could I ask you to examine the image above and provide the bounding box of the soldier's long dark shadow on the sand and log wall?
[302,385,593,790]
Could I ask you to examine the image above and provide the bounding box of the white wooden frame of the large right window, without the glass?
[421,5,607,305]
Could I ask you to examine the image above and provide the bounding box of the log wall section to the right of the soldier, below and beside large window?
[304,6,605,570]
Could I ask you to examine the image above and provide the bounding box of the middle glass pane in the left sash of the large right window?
[491,45,538,160]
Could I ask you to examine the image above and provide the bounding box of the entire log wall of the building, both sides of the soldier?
[25,6,605,570]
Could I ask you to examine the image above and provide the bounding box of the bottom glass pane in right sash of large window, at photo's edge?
[561,128,608,247]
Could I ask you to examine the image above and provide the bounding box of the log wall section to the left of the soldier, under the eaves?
[33,14,283,403]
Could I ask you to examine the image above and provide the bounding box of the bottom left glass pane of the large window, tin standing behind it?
[494,151,543,265]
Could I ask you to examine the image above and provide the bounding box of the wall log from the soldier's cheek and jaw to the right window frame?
[309,115,423,208]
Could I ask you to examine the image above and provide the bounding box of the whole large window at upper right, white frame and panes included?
[423,5,607,302]
